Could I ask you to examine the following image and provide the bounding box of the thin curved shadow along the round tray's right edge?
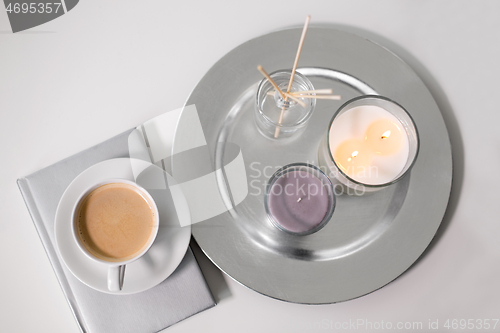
[316,24,464,272]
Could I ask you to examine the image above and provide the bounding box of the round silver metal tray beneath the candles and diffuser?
[172,28,452,304]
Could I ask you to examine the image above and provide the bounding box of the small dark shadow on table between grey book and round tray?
[189,237,232,304]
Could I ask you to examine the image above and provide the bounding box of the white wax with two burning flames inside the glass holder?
[329,105,409,185]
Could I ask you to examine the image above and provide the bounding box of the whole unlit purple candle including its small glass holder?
[265,163,335,235]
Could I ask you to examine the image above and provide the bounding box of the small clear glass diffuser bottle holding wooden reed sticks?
[254,70,316,139]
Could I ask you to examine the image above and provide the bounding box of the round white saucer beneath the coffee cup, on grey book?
[55,158,191,295]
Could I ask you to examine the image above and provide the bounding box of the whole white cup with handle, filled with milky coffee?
[73,179,159,291]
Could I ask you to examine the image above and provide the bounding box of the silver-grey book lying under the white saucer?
[18,130,215,333]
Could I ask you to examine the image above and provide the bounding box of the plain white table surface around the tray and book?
[0,0,500,333]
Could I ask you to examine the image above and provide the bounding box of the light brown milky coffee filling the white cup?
[76,183,156,262]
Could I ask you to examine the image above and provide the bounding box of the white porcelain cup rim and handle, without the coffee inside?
[71,179,160,291]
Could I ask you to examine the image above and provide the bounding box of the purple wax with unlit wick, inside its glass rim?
[268,170,330,233]
